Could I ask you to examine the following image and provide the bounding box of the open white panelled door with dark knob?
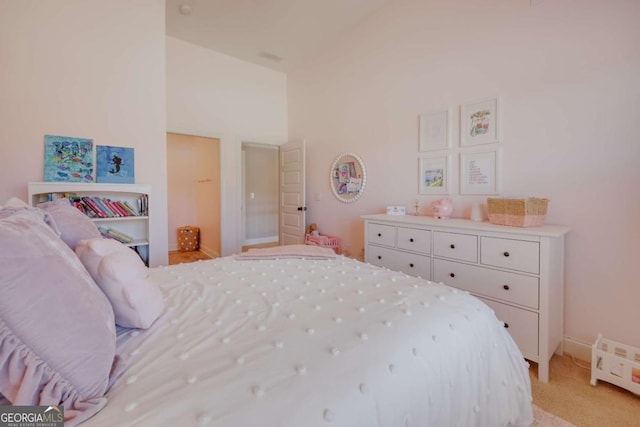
[280,141,307,245]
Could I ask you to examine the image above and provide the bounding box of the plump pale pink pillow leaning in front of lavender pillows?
[76,238,164,329]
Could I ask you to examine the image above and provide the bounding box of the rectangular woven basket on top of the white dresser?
[487,198,549,227]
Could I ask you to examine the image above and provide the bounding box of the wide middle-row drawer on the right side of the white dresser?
[433,259,540,310]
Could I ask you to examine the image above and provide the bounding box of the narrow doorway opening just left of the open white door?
[242,142,280,250]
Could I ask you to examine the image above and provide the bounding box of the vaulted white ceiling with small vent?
[166,0,393,72]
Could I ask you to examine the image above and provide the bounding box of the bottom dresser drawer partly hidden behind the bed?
[480,298,538,361]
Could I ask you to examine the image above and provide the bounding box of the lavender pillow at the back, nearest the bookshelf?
[38,199,101,250]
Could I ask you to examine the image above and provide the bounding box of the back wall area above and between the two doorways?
[167,37,287,255]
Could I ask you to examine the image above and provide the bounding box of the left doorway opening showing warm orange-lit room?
[167,132,222,259]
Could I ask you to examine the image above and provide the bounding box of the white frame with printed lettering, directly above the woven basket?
[460,150,499,195]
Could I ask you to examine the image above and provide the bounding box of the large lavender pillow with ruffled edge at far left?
[0,208,116,425]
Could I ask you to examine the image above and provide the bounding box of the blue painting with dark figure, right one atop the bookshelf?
[96,145,135,184]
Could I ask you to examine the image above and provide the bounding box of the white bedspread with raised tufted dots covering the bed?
[83,257,533,427]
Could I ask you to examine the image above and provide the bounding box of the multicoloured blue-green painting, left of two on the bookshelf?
[44,135,93,182]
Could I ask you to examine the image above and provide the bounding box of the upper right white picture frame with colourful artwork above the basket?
[460,98,500,147]
